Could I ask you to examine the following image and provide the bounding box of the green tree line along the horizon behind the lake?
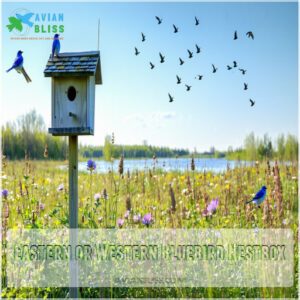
[1,110,298,161]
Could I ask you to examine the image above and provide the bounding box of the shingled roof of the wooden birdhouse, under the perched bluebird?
[44,51,102,84]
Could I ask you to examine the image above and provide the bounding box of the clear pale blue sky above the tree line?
[1,2,298,151]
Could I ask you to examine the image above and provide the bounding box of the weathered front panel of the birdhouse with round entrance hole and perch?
[52,77,88,128]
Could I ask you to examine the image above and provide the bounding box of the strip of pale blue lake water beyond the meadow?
[79,158,250,173]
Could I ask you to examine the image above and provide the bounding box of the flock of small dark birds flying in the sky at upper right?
[134,16,255,107]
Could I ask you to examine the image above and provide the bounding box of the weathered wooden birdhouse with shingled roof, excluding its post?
[44,51,102,135]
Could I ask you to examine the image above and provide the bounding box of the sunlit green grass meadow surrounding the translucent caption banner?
[2,161,298,298]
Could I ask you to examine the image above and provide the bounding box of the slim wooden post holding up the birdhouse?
[69,135,78,299]
